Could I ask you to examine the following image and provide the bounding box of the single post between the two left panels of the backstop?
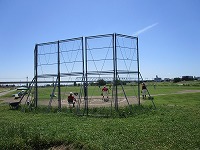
[58,41,61,110]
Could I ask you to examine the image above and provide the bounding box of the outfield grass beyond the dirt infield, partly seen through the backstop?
[3,81,200,101]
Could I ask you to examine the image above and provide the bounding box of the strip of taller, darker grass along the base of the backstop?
[21,105,155,118]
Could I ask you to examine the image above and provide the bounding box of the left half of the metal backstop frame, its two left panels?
[34,37,84,109]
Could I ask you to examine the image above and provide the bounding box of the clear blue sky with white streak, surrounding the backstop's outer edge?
[0,0,200,81]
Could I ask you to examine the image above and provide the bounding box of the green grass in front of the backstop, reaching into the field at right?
[0,82,200,150]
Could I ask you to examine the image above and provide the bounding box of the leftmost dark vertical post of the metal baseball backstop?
[34,44,38,108]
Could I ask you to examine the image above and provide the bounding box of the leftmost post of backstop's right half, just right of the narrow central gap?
[83,37,88,115]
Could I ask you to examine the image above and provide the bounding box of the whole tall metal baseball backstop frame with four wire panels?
[34,33,140,114]
